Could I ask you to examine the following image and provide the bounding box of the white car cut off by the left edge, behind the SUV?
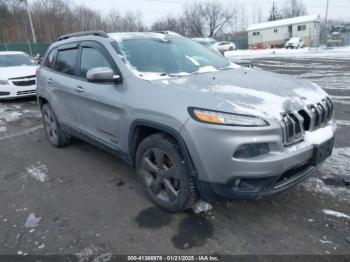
[0,52,38,100]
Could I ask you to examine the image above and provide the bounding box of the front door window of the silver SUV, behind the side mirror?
[80,47,112,78]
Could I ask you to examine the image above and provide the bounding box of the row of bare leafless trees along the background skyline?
[0,0,340,43]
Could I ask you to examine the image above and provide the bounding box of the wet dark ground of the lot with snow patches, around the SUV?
[0,56,350,261]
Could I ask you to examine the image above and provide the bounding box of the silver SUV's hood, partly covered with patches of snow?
[158,68,327,119]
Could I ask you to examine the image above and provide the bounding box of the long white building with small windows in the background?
[247,15,320,48]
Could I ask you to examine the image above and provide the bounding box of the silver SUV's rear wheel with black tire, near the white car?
[41,104,70,147]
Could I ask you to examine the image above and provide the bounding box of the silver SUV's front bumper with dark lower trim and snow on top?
[182,117,336,198]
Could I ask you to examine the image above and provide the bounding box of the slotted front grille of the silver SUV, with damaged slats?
[281,97,334,146]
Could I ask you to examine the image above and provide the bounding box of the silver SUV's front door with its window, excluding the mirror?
[77,41,124,150]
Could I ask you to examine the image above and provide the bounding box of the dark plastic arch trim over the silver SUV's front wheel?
[128,120,197,176]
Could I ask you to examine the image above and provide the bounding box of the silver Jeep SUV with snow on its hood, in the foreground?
[37,31,336,212]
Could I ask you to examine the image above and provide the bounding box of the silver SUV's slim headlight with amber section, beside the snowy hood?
[188,107,269,126]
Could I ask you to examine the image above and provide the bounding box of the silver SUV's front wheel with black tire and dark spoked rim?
[135,133,198,213]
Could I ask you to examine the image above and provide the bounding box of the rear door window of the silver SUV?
[56,48,78,75]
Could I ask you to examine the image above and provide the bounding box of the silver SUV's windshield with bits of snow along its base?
[116,37,232,76]
